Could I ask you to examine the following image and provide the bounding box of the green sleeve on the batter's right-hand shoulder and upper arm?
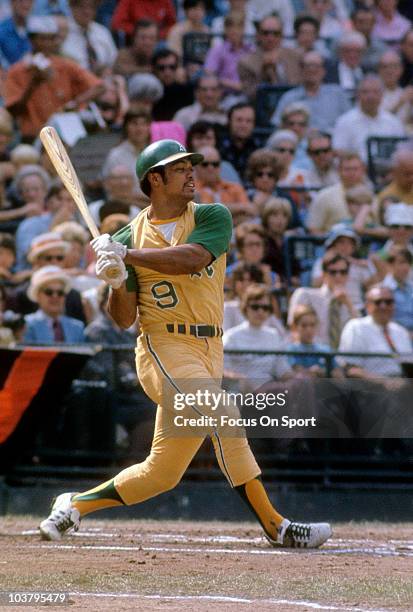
[186,204,232,259]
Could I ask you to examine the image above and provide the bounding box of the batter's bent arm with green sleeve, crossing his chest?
[124,204,232,275]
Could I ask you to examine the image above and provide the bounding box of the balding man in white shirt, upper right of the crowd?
[333,75,405,160]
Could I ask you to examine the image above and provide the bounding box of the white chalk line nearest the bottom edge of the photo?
[69,591,390,612]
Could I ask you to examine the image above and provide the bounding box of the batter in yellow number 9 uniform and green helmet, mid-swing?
[40,140,331,548]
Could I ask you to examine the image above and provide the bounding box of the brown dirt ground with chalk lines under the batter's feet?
[0,517,413,612]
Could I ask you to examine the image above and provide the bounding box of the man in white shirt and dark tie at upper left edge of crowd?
[62,0,118,72]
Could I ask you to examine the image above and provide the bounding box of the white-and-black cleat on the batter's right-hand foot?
[265,519,332,548]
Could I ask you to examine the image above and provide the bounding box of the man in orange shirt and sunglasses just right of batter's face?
[195,147,251,214]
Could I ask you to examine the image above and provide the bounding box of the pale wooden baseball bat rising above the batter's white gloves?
[40,125,100,238]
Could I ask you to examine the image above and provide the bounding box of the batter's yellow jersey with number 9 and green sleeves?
[113,202,232,331]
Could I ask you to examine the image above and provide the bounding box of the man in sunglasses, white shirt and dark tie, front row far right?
[339,286,413,379]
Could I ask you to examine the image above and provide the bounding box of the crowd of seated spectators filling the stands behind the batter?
[0,0,413,450]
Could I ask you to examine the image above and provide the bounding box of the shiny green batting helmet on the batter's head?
[136,140,204,181]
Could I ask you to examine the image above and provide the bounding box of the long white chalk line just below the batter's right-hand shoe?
[22,543,413,557]
